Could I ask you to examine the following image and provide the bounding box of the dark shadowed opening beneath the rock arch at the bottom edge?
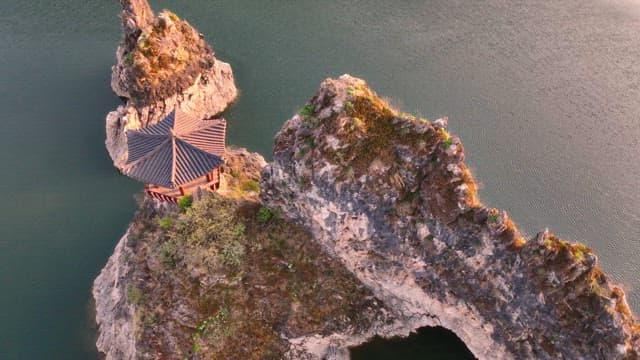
[350,326,475,360]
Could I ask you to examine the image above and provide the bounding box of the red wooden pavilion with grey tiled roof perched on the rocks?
[123,109,227,203]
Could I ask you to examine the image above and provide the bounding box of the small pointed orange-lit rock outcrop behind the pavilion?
[105,0,238,168]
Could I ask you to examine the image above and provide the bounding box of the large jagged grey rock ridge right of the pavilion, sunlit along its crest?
[261,75,640,359]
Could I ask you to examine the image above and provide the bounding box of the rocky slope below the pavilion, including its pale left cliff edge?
[93,149,394,360]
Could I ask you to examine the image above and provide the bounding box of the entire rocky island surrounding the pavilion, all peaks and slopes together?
[93,0,640,359]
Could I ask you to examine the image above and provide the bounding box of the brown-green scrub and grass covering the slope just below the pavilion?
[128,195,384,359]
